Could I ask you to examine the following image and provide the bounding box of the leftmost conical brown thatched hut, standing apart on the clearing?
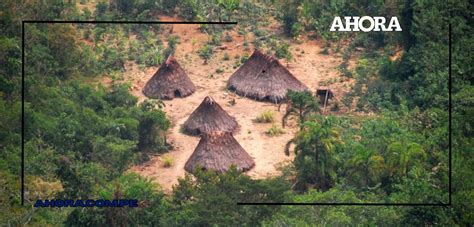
[143,56,196,99]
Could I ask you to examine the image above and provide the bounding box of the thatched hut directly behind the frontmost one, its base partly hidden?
[183,96,238,135]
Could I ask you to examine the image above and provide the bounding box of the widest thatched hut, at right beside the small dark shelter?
[227,50,308,103]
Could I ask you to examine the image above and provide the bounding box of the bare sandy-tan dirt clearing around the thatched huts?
[124,18,351,192]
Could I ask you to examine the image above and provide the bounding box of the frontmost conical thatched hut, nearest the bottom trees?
[184,132,255,173]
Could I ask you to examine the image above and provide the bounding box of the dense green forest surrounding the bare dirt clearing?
[0,0,474,226]
